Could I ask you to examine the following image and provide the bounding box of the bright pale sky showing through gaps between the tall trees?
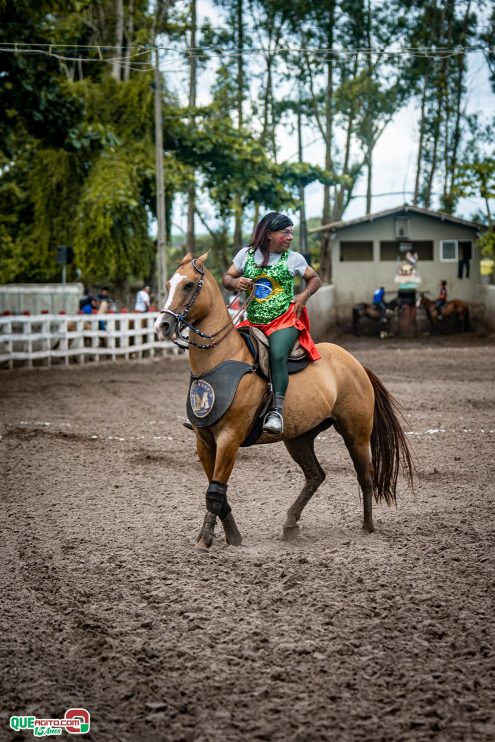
[163,0,495,233]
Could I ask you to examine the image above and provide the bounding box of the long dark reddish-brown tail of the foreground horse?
[364,368,414,505]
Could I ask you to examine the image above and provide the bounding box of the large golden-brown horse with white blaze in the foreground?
[155,253,413,549]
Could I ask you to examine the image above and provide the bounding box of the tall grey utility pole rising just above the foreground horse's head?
[154,46,167,308]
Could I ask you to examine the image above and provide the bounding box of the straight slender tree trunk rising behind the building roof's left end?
[320,0,335,283]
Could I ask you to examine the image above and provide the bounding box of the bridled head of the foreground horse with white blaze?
[154,253,208,340]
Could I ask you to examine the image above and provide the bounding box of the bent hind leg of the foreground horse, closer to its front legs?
[283,428,325,540]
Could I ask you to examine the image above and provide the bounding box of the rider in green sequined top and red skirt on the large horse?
[223,211,320,435]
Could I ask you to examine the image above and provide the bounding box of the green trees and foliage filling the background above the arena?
[0,0,495,283]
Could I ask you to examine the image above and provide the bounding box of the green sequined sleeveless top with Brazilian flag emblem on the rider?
[243,250,294,325]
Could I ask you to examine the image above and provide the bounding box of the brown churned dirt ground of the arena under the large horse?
[0,336,495,742]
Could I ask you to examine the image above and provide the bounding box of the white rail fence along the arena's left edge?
[0,312,178,368]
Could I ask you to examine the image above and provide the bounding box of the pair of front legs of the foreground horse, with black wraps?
[195,431,242,551]
